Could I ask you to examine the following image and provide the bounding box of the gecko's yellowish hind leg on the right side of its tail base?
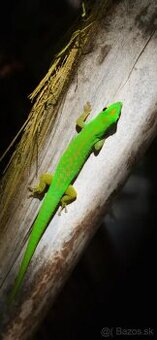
[58,185,77,216]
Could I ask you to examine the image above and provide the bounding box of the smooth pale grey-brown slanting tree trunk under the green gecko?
[0,0,157,340]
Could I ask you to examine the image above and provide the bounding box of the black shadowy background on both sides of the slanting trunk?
[0,0,157,340]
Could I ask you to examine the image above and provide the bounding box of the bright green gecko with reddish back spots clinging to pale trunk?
[9,102,122,301]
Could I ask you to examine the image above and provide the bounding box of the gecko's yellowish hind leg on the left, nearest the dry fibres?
[28,172,53,197]
